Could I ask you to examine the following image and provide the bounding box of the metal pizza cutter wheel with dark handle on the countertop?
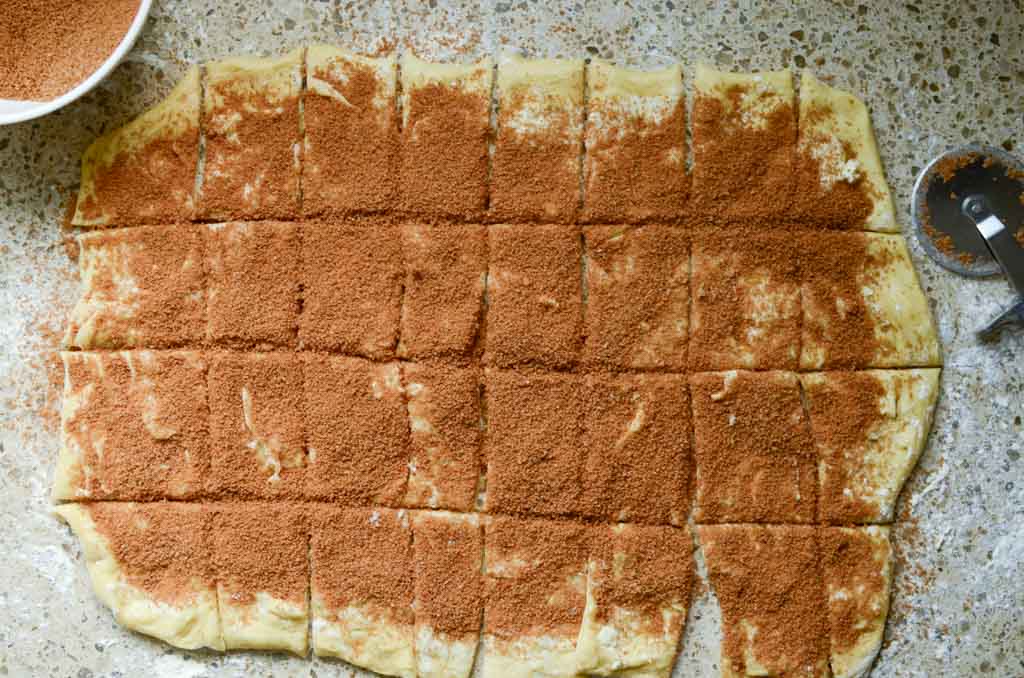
[911,145,1024,341]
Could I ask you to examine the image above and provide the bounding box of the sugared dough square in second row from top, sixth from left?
[583,224,690,371]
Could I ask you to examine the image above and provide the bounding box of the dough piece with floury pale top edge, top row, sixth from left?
[584,59,690,223]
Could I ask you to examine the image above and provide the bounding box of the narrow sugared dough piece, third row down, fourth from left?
[401,363,482,511]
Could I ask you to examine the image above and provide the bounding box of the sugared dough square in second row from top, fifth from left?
[484,224,583,368]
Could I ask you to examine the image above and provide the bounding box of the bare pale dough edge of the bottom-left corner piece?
[54,504,224,650]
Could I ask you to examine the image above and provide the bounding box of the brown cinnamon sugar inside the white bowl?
[0,0,139,101]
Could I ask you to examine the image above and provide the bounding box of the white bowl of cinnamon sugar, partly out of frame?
[0,0,153,125]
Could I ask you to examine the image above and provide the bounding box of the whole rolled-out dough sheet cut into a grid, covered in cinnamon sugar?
[55,45,940,678]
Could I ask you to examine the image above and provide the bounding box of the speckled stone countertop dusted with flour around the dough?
[0,0,1024,678]
